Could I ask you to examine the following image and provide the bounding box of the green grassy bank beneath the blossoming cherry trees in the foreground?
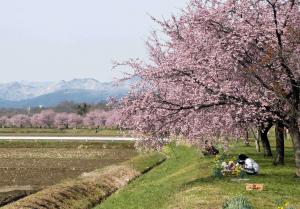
[95,132,300,209]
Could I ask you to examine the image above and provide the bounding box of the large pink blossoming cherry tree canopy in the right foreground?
[121,0,300,176]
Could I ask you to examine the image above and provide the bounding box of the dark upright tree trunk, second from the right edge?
[274,121,284,165]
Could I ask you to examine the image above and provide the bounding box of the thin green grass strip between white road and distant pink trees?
[0,128,128,136]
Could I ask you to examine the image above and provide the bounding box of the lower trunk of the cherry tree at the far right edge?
[289,119,300,177]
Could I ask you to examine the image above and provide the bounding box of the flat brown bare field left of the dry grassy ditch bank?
[0,142,136,206]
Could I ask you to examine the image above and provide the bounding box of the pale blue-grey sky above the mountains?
[0,0,188,83]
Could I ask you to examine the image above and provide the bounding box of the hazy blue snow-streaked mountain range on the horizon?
[0,78,131,108]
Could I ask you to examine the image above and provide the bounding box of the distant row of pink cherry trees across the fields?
[0,110,120,129]
